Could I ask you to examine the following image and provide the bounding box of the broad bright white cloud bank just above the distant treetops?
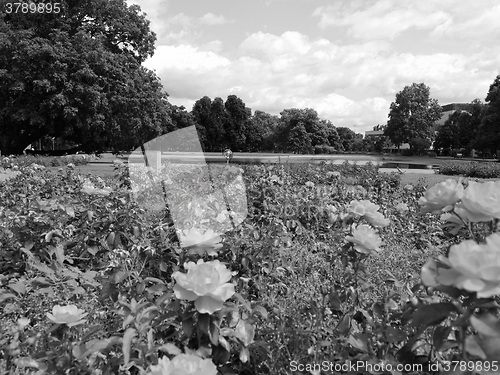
[146,27,500,132]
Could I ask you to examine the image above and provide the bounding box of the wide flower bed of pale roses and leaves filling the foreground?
[0,159,500,374]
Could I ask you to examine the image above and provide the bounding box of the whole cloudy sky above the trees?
[127,0,500,133]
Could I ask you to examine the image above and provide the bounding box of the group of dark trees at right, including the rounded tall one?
[384,75,500,155]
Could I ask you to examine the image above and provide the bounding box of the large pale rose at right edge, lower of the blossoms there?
[421,233,500,298]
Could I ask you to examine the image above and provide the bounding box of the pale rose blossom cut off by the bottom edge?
[147,354,217,375]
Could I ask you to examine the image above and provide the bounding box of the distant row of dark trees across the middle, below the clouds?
[170,95,364,154]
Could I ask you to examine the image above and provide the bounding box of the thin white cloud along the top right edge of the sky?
[312,0,500,41]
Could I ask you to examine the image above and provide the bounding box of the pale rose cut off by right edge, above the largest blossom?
[462,180,500,222]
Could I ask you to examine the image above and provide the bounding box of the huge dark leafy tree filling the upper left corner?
[0,0,173,154]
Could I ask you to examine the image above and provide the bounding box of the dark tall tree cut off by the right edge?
[475,75,500,152]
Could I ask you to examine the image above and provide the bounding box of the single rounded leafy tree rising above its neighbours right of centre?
[384,83,442,148]
